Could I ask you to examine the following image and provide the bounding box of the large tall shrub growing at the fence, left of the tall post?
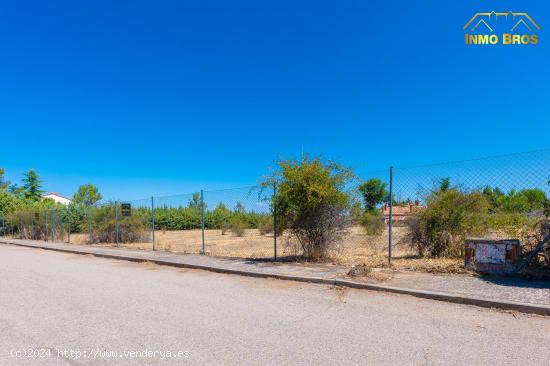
[263,156,352,259]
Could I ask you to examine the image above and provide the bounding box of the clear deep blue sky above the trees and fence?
[0,0,550,199]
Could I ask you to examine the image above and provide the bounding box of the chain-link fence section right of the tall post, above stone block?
[393,150,550,257]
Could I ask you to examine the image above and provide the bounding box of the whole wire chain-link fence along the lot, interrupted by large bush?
[0,150,550,265]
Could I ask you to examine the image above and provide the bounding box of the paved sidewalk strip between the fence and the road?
[0,239,550,315]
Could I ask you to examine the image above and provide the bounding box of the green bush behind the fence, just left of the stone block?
[411,188,489,257]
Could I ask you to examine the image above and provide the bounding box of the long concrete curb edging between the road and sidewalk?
[4,240,550,316]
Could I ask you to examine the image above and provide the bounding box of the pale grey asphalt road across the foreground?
[0,245,550,365]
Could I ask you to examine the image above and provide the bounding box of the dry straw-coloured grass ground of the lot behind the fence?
[67,227,465,273]
